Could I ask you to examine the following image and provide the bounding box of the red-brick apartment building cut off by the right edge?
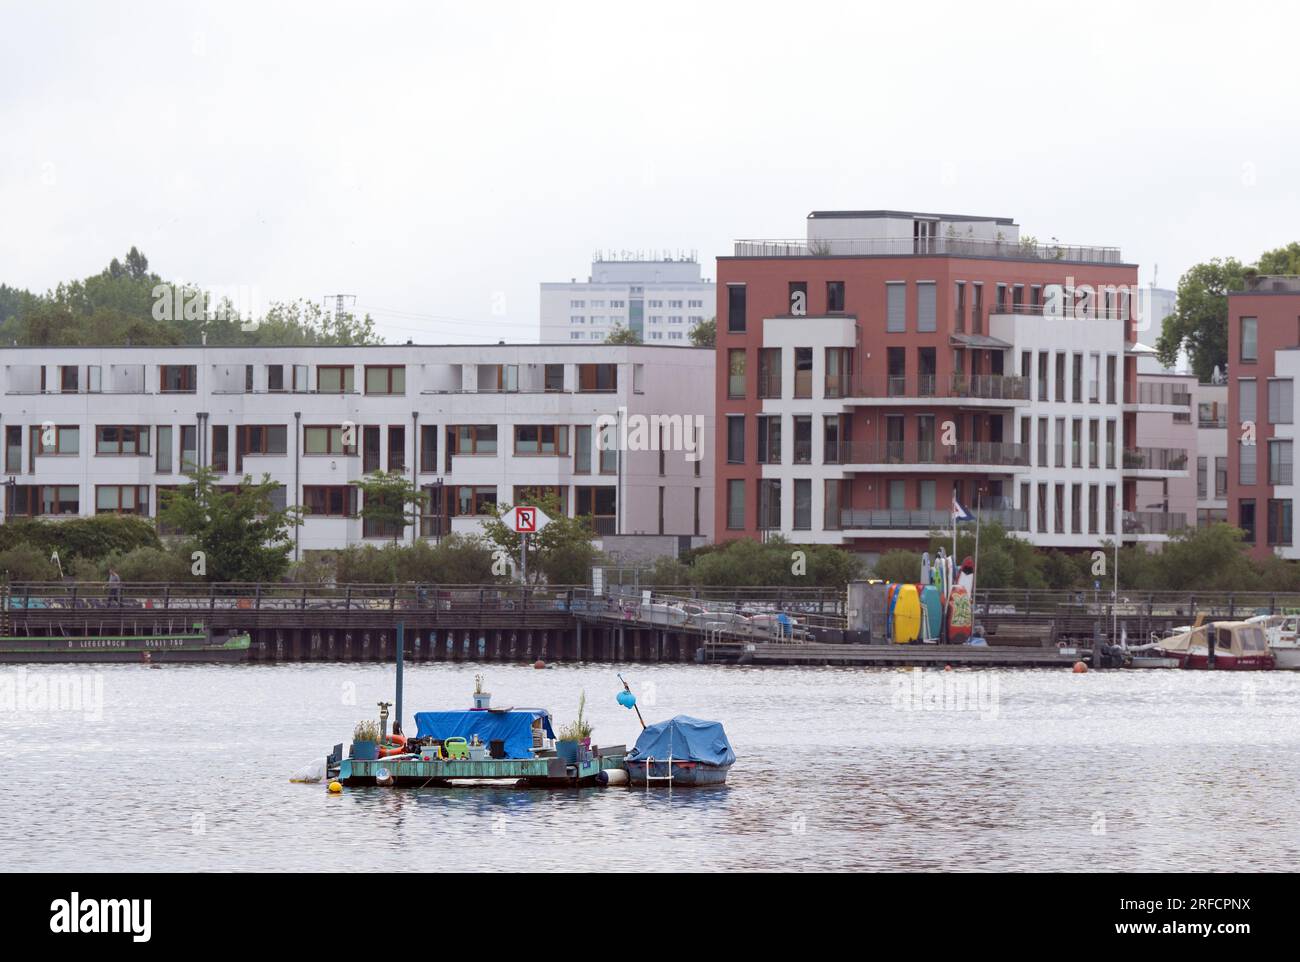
[1226,276,1300,558]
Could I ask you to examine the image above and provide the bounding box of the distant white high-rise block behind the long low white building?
[541,252,716,346]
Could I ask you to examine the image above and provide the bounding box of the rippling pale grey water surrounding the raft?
[0,664,1300,871]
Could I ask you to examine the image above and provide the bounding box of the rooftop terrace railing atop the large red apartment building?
[733,237,1123,264]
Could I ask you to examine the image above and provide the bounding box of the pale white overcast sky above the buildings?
[0,0,1300,343]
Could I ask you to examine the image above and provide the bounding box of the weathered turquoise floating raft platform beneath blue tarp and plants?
[338,745,627,788]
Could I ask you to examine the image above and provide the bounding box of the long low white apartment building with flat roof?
[0,345,714,550]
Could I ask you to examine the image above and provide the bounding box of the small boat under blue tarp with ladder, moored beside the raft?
[623,715,736,788]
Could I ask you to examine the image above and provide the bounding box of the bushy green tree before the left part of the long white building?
[159,468,302,581]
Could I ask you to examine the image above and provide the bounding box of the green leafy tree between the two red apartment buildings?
[1156,257,1245,381]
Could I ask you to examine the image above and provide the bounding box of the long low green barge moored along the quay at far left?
[0,624,252,664]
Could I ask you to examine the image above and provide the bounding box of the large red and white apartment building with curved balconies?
[715,211,1188,555]
